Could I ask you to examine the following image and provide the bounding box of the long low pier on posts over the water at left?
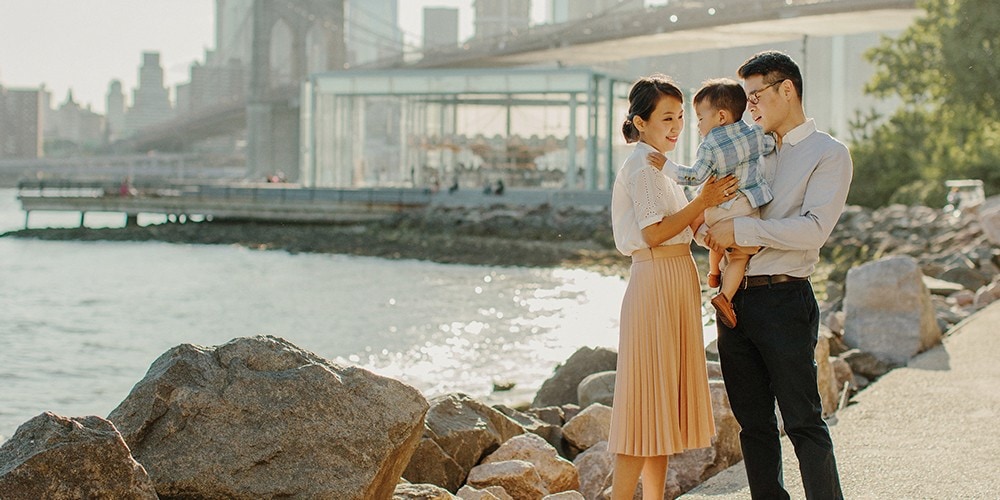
[18,180,431,228]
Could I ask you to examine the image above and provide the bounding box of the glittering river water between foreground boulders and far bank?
[0,189,648,442]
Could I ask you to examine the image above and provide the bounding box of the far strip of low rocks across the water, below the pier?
[3,207,628,275]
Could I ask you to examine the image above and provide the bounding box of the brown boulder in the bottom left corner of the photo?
[0,412,157,500]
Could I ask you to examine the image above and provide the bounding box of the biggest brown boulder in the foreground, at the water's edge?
[108,336,428,500]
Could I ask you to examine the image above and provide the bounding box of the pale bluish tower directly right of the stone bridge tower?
[344,0,403,65]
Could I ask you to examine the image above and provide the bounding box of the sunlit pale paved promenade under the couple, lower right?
[681,302,1000,500]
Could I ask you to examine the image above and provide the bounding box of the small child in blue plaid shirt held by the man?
[650,78,774,328]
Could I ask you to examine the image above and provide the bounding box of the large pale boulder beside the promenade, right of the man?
[844,256,941,365]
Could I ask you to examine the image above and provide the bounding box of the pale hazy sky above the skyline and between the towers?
[0,0,544,114]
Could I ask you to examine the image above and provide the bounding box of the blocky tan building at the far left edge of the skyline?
[0,86,44,159]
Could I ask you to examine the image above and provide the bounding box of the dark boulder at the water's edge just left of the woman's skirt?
[531,347,618,408]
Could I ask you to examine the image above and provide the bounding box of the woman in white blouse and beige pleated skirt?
[608,75,736,500]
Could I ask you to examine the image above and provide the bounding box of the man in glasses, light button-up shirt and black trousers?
[705,51,853,499]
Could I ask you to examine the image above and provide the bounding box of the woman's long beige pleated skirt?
[608,245,715,456]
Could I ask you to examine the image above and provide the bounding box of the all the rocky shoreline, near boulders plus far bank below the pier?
[0,200,1000,500]
